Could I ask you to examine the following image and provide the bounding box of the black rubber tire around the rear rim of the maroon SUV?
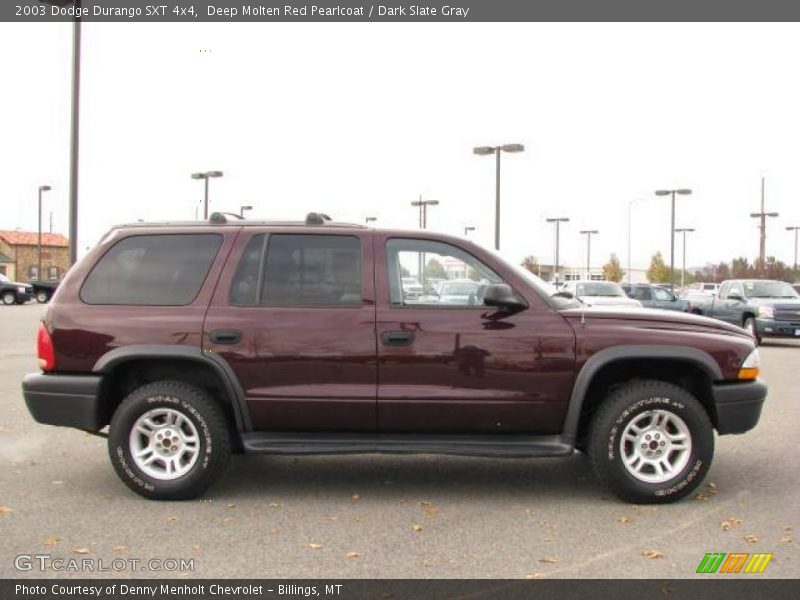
[108,381,231,500]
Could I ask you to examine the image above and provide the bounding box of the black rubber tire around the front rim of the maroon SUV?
[588,380,714,504]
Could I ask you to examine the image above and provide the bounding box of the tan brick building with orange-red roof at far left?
[0,231,69,282]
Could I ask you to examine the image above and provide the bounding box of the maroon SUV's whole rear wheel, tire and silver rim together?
[108,381,231,500]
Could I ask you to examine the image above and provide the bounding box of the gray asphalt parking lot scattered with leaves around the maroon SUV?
[0,304,800,578]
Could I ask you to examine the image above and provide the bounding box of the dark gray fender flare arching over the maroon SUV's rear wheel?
[92,344,252,432]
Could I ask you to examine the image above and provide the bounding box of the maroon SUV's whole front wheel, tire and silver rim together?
[588,381,714,504]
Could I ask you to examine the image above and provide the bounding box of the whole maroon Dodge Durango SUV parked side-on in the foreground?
[22,213,766,502]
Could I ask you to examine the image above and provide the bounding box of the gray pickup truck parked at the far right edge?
[692,279,800,343]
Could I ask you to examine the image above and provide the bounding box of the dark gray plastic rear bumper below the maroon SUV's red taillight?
[22,373,105,431]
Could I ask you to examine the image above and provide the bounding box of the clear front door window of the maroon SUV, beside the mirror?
[386,238,503,308]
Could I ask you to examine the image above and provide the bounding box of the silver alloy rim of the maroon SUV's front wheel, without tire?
[619,410,692,483]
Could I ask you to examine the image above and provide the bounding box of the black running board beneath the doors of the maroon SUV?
[242,432,573,458]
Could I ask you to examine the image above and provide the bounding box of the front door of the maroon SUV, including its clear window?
[375,234,575,434]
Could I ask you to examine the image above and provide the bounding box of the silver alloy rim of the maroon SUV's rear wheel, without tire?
[130,408,200,480]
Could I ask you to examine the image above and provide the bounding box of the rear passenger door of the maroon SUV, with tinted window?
[204,227,377,431]
